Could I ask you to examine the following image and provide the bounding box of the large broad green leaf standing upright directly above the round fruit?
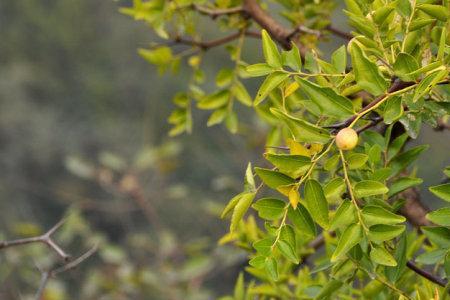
[349,42,388,96]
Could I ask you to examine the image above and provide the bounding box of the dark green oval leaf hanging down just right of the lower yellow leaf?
[304,179,329,229]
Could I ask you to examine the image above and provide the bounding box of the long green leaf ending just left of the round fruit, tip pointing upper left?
[270,108,331,144]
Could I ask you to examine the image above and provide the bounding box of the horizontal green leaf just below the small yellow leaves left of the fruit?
[264,153,311,178]
